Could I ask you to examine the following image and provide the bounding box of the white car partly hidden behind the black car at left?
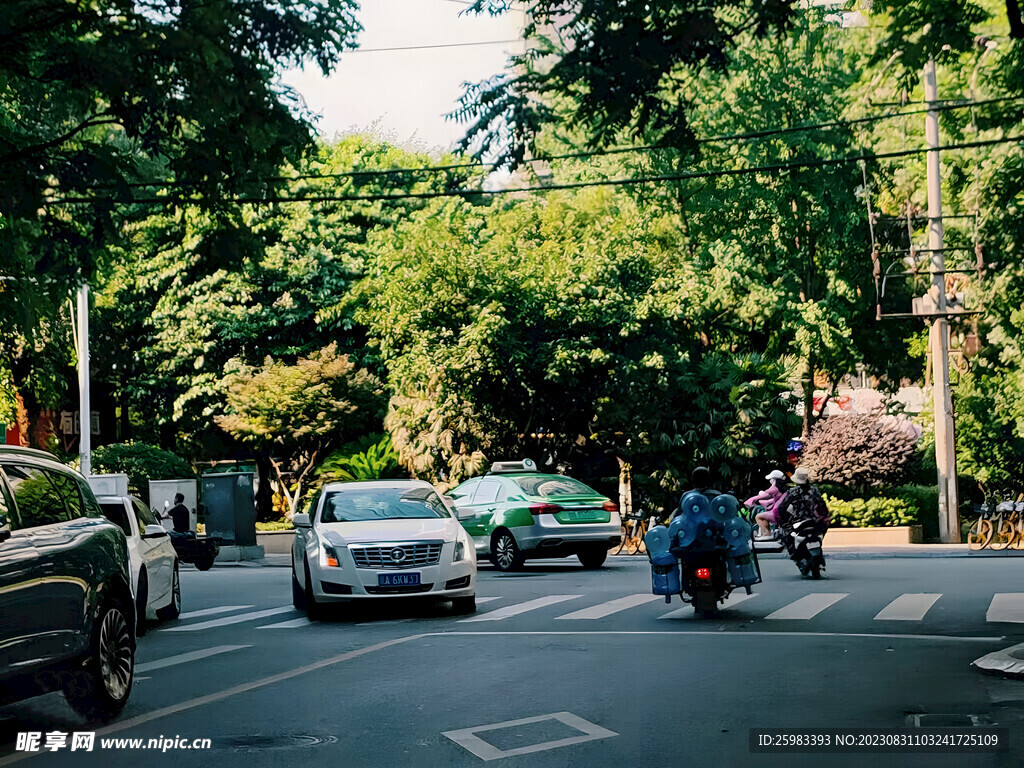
[97,496,181,635]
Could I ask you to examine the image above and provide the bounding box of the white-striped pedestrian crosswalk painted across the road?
[161,590,1024,634]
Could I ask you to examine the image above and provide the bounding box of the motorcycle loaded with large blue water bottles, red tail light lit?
[645,493,761,618]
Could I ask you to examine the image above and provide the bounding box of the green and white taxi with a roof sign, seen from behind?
[449,459,622,570]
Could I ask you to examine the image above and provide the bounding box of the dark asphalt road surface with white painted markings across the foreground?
[0,558,1024,768]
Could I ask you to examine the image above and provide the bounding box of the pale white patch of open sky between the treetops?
[283,0,522,153]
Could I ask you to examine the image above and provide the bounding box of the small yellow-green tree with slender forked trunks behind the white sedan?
[216,344,382,517]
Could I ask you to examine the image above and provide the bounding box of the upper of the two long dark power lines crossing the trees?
[74,96,1022,189]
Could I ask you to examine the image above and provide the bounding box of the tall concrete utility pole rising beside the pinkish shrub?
[925,59,961,544]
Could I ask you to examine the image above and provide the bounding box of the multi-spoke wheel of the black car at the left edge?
[65,600,135,721]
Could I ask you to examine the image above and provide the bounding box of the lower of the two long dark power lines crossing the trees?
[46,134,1024,205]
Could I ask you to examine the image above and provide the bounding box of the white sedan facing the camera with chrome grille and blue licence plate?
[292,480,476,620]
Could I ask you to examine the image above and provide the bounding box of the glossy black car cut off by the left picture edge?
[0,445,135,720]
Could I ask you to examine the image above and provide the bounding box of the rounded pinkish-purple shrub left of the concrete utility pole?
[803,415,919,489]
